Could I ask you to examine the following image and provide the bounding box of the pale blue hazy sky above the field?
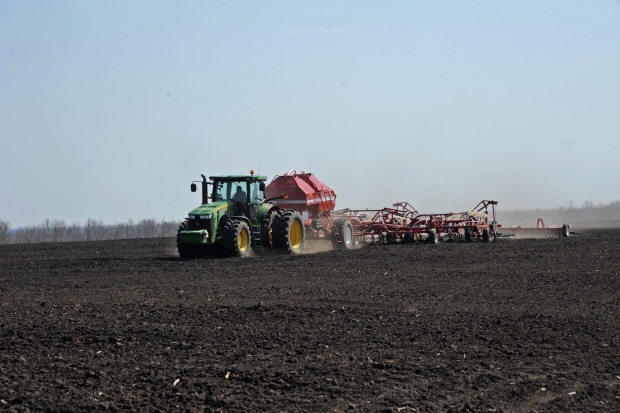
[0,0,620,227]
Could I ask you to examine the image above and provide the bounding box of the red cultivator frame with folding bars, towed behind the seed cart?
[333,200,500,244]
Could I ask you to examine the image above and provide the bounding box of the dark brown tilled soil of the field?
[0,230,620,412]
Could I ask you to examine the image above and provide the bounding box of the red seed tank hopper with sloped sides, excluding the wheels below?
[265,169,336,221]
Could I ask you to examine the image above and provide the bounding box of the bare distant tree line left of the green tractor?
[0,218,179,244]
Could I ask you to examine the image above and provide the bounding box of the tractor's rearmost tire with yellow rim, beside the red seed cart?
[271,209,305,255]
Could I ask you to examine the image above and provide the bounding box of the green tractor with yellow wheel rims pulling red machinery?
[177,171,305,258]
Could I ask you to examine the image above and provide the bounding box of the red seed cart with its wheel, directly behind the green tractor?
[265,169,346,248]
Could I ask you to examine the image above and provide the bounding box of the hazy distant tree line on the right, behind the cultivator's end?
[498,200,620,226]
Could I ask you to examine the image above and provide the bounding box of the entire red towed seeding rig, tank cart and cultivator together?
[265,169,572,249]
